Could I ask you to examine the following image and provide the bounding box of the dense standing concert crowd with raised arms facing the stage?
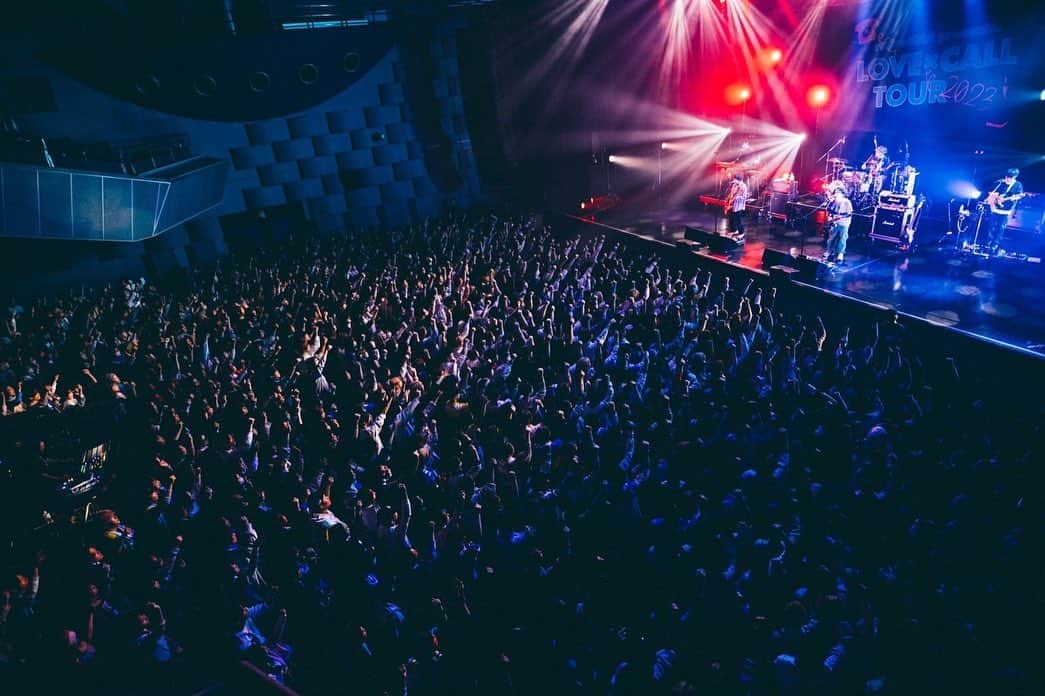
[0,215,1045,695]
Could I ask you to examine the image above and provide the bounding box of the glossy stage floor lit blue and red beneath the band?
[597,204,1045,357]
